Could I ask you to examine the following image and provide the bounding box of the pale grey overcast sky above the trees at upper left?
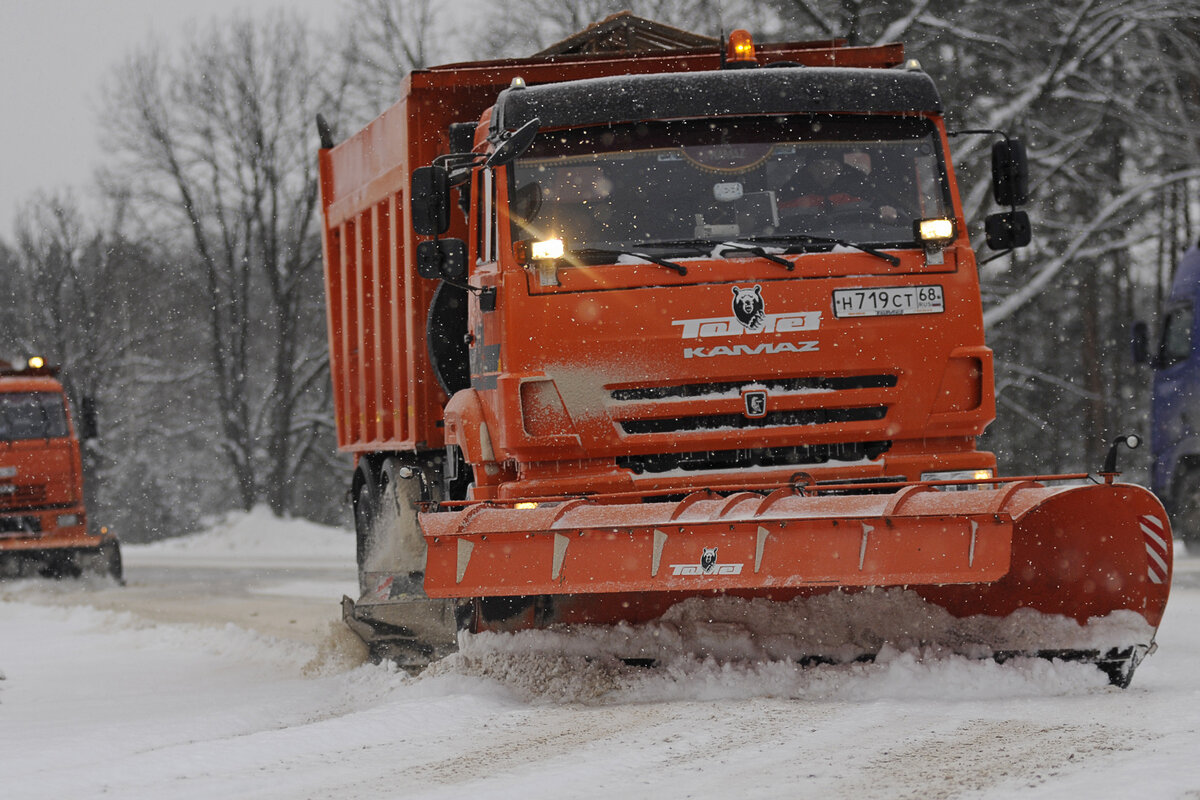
[0,0,343,243]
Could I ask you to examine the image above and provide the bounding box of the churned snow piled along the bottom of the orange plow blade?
[424,589,1153,704]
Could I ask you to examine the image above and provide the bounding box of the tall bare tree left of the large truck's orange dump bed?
[99,14,340,513]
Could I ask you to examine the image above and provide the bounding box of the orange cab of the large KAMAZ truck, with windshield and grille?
[434,65,995,500]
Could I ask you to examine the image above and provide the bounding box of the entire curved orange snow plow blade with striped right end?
[420,479,1171,686]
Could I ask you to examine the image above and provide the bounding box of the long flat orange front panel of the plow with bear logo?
[420,486,1013,597]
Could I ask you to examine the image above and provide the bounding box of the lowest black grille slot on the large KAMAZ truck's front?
[617,441,892,474]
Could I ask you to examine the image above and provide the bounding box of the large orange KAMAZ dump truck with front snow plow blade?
[318,26,1171,685]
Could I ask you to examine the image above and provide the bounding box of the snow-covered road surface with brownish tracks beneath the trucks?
[0,513,1200,800]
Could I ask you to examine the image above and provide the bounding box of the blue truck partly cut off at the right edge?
[1133,245,1200,551]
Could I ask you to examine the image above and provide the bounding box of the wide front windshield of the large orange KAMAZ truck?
[510,115,949,251]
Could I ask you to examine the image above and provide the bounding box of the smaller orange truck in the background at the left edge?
[0,359,121,581]
